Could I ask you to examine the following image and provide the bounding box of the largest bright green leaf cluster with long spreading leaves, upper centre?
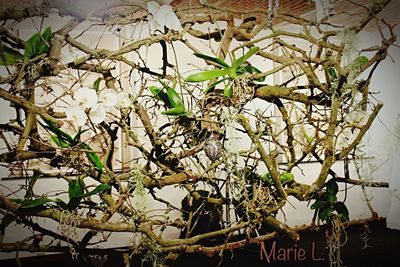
[185,46,264,97]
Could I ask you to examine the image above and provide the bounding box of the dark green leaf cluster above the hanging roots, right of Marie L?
[311,179,349,224]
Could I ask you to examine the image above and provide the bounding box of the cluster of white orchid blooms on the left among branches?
[65,87,131,127]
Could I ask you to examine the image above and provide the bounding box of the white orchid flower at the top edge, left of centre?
[147,1,183,32]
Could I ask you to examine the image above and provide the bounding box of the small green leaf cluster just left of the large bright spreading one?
[149,81,187,116]
